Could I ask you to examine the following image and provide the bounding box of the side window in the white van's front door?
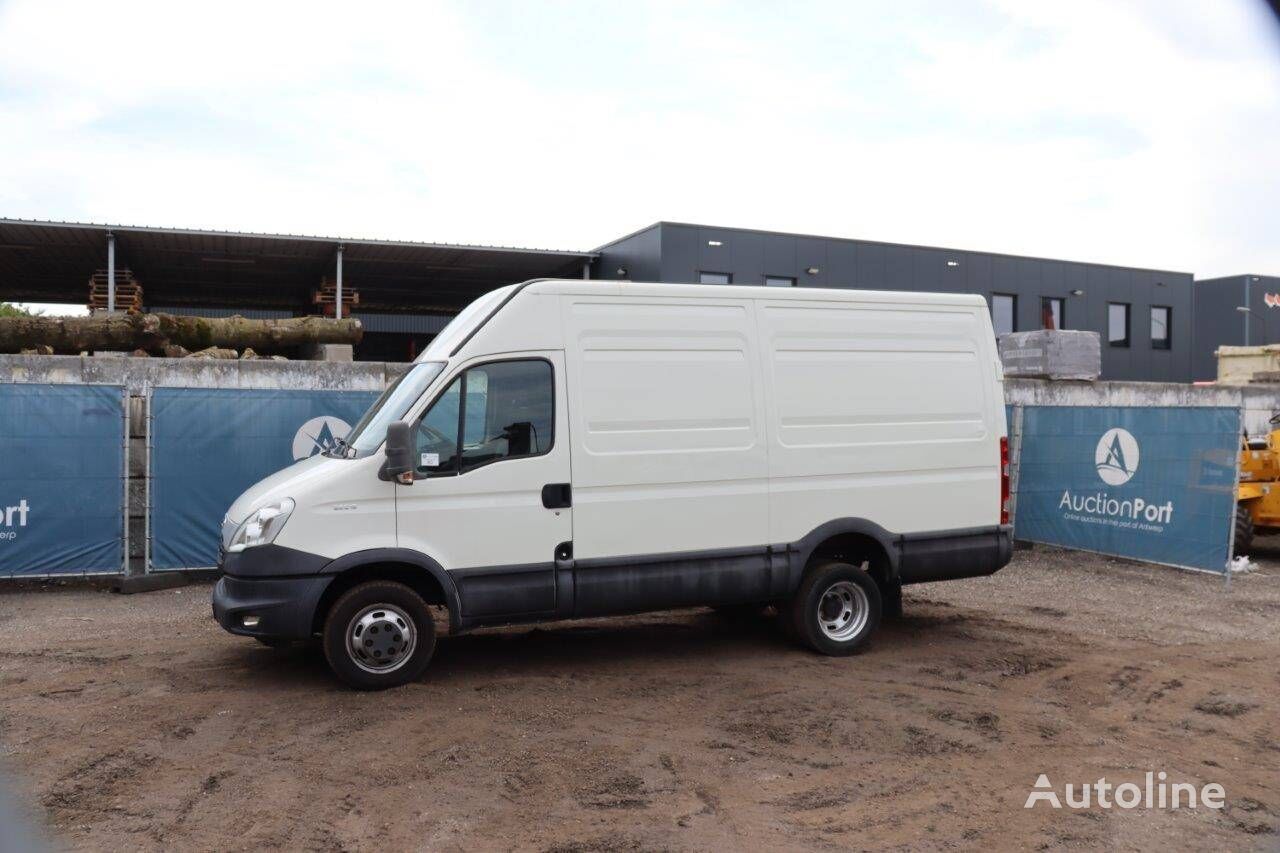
[416,359,556,476]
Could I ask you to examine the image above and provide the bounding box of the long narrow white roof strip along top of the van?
[520,278,987,307]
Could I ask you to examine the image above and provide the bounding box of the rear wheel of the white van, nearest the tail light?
[785,562,883,654]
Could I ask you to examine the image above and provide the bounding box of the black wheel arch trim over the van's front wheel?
[311,548,462,634]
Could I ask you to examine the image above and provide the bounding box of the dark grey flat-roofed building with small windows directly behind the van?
[591,222,1192,382]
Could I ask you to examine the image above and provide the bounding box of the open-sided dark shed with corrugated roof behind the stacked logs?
[0,219,595,315]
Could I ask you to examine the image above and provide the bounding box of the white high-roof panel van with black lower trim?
[214,280,1011,689]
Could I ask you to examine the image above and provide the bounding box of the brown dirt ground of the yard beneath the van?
[0,542,1280,850]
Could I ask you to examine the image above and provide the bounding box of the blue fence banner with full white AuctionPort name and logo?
[1015,406,1240,573]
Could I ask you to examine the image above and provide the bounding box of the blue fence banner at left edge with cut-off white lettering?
[0,384,124,576]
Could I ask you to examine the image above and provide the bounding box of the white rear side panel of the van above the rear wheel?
[756,298,1004,542]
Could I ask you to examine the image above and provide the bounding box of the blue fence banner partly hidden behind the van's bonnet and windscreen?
[150,388,378,569]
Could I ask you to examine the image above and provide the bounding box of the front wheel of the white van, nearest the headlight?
[323,580,435,690]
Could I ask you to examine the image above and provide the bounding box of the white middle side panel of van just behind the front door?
[562,295,768,558]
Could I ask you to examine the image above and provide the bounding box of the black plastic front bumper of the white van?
[214,575,333,639]
